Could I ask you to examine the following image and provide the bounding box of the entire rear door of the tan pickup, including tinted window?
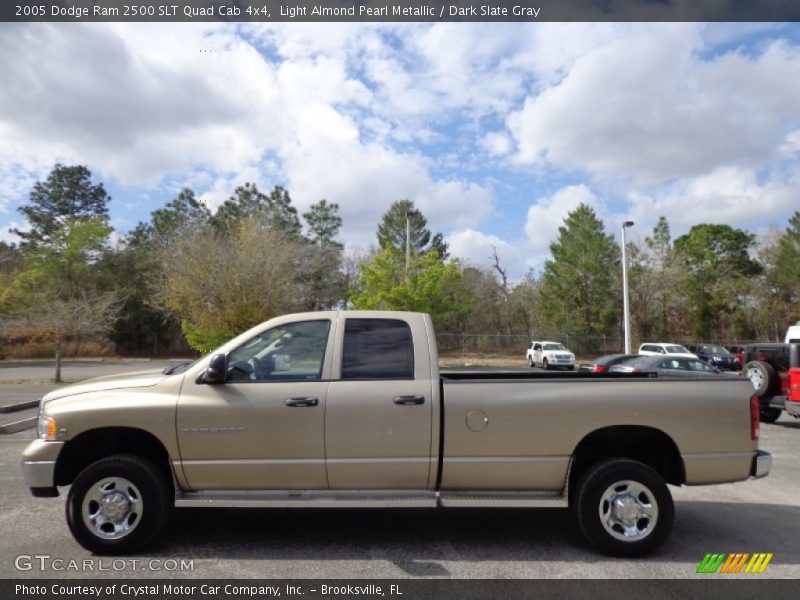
[325,313,438,490]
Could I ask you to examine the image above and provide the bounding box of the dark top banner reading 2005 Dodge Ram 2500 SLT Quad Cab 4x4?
[0,0,800,22]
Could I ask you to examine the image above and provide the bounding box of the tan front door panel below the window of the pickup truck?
[177,381,328,490]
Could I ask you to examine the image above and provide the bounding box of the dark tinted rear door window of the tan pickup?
[342,319,414,379]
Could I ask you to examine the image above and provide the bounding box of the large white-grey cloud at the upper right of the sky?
[507,23,800,184]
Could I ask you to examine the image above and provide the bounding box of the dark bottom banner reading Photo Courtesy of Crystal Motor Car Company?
[0,576,798,600]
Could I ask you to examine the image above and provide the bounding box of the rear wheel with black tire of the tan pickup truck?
[573,458,675,558]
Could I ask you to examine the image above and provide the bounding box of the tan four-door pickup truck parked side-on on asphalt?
[22,311,771,556]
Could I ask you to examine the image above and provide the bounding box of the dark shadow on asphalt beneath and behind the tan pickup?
[151,501,800,577]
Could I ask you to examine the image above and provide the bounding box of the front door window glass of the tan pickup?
[228,319,330,381]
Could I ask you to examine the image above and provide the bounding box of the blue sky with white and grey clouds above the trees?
[0,23,800,278]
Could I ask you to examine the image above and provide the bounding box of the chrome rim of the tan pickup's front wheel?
[81,477,142,540]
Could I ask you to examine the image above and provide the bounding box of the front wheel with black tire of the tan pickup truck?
[67,454,173,555]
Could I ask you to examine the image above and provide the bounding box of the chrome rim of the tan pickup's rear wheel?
[598,480,658,542]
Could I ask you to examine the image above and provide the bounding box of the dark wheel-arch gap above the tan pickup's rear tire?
[569,425,686,489]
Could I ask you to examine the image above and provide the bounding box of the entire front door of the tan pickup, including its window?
[177,319,331,490]
